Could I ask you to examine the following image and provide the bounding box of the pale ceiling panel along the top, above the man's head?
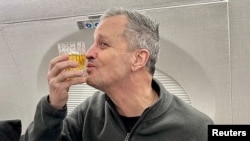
[0,0,223,23]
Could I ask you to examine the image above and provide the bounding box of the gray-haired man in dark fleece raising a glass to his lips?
[23,8,213,141]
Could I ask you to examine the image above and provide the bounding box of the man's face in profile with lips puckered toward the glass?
[86,16,131,90]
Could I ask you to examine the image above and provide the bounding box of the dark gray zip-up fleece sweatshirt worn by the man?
[22,80,213,141]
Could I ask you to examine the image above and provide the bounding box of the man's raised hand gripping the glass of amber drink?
[47,54,86,109]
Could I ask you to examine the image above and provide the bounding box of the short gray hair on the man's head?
[100,8,160,75]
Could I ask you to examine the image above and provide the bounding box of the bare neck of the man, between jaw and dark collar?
[108,77,158,117]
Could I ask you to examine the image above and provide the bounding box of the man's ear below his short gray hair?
[132,49,150,71]
